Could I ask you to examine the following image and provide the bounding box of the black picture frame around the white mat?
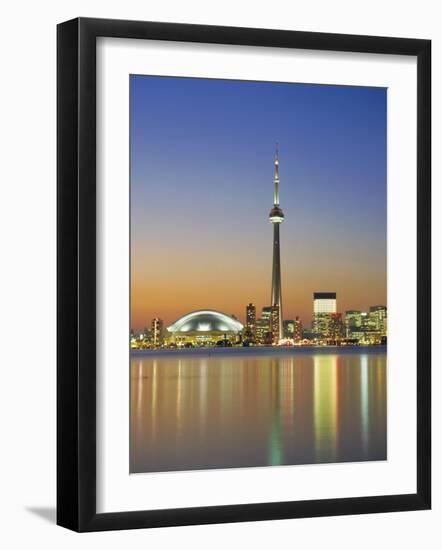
[57,18,431,531]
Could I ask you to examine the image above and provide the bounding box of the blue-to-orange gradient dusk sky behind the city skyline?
[130,75,387,329]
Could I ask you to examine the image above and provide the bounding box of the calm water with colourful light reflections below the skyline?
[130,348,386,472]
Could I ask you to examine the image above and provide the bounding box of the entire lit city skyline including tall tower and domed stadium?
[130,146,387,349]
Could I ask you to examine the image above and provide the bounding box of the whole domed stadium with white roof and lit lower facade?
[167,309,244,346]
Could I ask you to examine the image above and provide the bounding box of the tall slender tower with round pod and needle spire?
[269,144,284,340]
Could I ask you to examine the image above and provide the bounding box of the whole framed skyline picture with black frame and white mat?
[57,18,431,531]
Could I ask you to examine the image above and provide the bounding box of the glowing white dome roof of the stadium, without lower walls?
[167,309,243,336]
